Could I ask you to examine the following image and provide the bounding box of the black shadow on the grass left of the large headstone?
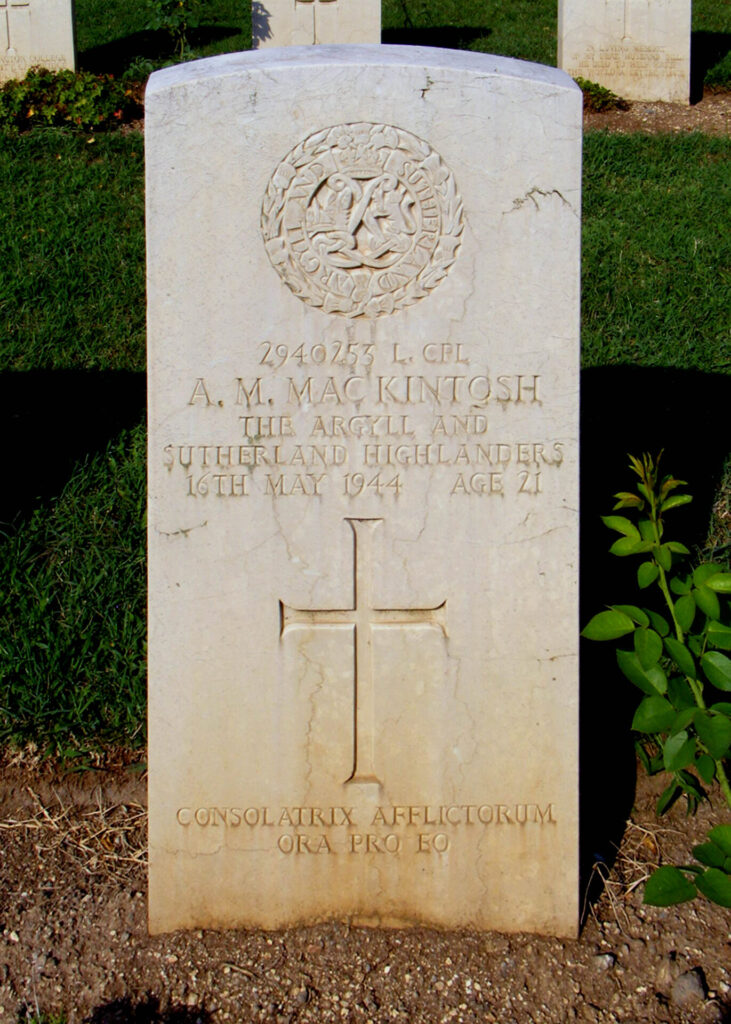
[0,371,145,523]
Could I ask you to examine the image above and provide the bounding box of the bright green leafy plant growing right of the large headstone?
[582,455,731,906]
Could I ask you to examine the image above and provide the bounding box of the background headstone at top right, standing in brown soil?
[558,0,691,103]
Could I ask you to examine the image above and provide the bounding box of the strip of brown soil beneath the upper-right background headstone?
[584,90,731,135]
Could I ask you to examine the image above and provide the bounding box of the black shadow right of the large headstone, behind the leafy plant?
[581,366,731,917]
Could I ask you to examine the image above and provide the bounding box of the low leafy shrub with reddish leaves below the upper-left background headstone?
[0,68,139,133]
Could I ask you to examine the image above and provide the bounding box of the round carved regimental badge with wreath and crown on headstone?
[261,123,464,317]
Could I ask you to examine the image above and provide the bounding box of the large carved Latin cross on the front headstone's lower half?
[280,519,446,782]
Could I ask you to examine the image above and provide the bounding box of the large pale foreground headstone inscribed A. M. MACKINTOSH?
[145,46,582,935]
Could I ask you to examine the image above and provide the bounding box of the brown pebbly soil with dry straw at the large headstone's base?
[0,757,731,1024]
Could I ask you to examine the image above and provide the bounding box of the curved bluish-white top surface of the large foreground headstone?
[146,44,578,96]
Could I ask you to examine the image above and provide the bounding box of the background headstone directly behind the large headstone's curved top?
[251,0,381,49]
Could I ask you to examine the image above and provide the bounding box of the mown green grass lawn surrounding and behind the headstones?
[0,0,731,753]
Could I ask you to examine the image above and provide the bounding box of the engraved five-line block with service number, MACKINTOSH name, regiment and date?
[163,352,567,504]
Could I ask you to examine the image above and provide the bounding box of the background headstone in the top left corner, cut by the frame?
[0,0,76,82]
